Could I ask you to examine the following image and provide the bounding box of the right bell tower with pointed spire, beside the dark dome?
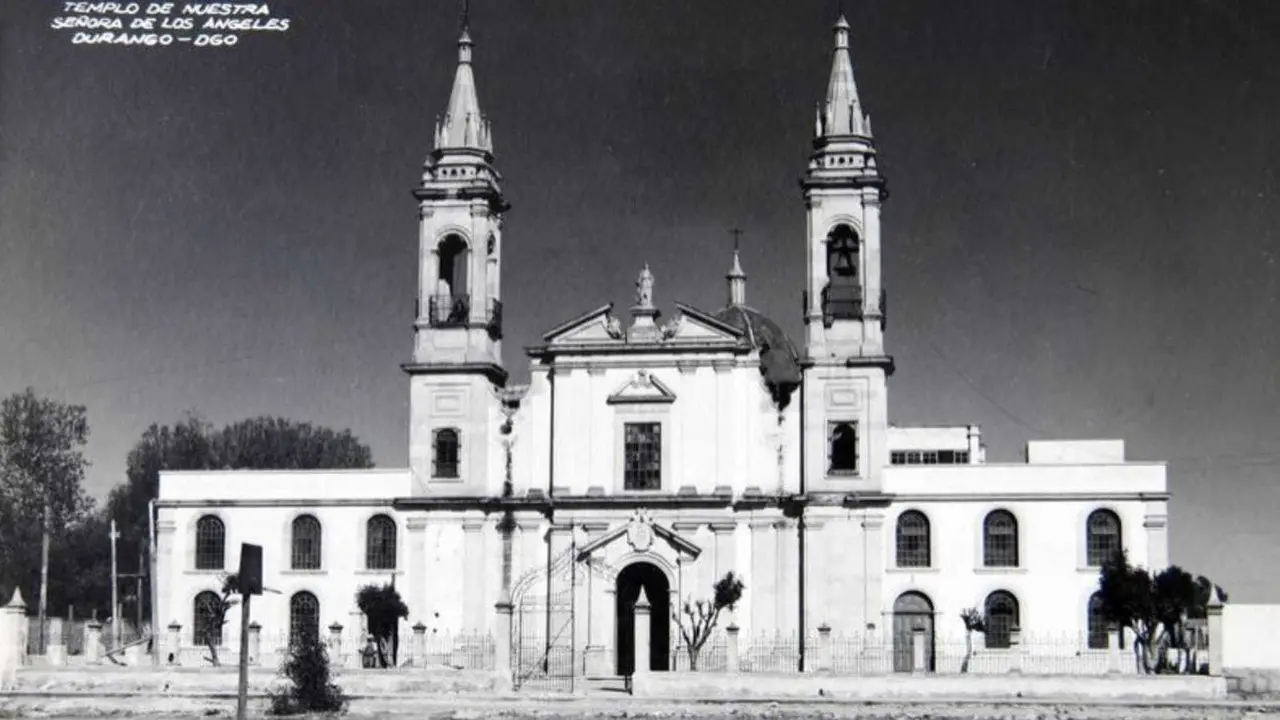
[800,17,893,492]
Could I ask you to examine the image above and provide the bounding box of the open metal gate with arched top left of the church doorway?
[511,547,585,692]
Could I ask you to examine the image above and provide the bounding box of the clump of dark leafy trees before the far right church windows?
[1098,550,1226,673]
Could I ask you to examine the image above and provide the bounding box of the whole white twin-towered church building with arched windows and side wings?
[155,19,1169,675]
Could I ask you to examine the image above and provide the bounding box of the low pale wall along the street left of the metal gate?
[5,666,511,696]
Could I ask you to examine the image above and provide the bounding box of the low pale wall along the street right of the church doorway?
[631,673,1228,701]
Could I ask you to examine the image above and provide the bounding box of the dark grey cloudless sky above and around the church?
[0,0,1280,602]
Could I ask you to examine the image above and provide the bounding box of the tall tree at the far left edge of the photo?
[0,388,93,632]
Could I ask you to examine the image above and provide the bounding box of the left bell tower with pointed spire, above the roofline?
[403,17,509,495]
